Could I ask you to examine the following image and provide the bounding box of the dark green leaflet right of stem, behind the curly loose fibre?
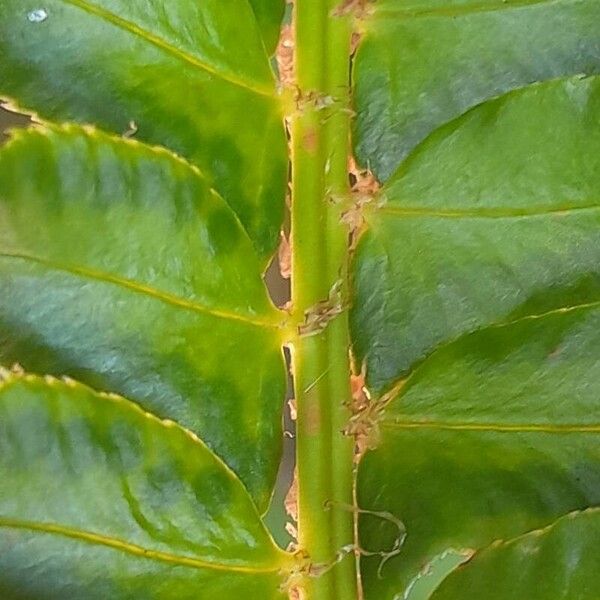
[359,304,600,600]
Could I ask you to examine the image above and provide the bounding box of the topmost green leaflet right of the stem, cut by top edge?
[354,0,600,181]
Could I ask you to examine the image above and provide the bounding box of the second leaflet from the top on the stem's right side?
[352,77,600,393]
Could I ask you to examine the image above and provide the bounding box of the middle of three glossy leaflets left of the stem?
[0,126,285,508]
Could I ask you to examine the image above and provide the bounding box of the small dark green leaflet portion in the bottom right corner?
[432,510,600,600]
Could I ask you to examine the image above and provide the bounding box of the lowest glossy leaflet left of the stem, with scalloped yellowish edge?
[0,374,286,600]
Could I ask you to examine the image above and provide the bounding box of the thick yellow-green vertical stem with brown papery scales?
[291,0,357,600]
